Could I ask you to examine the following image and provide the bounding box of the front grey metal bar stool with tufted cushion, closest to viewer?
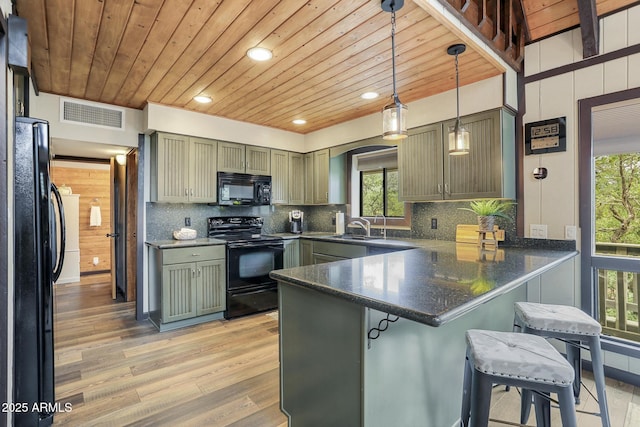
[460,329,577,427]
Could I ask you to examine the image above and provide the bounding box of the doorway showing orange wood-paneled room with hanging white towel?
[51,148,138,308]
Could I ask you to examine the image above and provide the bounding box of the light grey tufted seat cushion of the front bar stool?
[466,329,574,387]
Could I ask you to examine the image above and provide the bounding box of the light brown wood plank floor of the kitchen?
[54,275,640,427]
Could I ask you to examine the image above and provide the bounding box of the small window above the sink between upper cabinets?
[350,147,411,226]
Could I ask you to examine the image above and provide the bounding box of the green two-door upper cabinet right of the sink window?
[398,110,515,201]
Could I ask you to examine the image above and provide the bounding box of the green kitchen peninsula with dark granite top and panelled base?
[271,241,577,427]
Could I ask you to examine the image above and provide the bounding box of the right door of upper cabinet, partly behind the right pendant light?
[443,110,502,199]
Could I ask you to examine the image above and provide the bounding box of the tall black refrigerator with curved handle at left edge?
[13,117,65,426]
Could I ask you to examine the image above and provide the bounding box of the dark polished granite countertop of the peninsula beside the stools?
[271,241,577,326]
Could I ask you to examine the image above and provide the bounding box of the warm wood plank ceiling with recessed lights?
[15,0,631,133]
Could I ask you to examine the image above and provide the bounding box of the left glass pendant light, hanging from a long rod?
[381,0,407,139]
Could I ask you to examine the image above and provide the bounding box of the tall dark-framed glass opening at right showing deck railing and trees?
[579,89,640,351]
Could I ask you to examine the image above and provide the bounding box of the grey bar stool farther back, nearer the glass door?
[514,302,611,427]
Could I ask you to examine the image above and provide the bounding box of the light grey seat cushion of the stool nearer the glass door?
[514,302,602,335]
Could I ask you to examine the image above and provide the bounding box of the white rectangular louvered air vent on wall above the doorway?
[60,98,124,130]
